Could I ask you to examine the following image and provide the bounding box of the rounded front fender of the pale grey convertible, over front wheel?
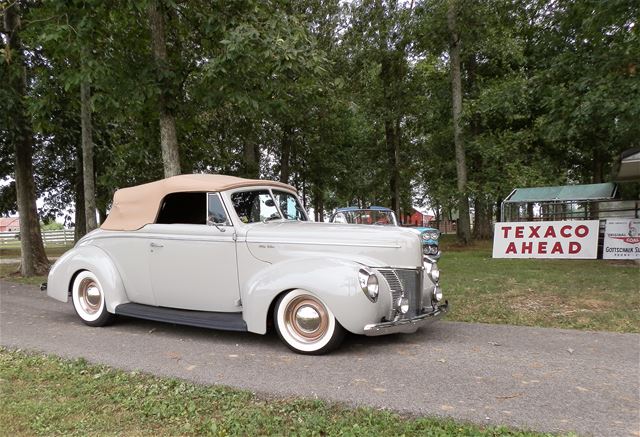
[242,257,391,334]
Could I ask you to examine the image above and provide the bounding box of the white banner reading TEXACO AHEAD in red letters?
[493,220,599,259]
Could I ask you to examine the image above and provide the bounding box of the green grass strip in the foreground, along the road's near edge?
[0,349,568,437]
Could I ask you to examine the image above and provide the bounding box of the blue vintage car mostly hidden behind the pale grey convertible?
[329,206,440,258]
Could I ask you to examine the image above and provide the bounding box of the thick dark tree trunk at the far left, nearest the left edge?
[4,2,49,276]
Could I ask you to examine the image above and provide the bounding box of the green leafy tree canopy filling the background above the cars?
[0,0,640,247]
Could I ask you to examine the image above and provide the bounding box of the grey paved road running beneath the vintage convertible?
[0,281,640,437]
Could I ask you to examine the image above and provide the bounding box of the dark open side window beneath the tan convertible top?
[156,193,207,225]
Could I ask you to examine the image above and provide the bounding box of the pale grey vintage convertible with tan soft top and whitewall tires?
[47,174,448,354]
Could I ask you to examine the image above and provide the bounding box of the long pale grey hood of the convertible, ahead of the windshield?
[246,221,422,268]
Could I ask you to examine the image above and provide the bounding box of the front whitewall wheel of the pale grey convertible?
[273,290,345,355]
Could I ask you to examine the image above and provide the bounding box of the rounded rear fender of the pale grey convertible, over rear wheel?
[47,244,129,313]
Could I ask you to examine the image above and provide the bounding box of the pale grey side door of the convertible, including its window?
[148,193,241,312]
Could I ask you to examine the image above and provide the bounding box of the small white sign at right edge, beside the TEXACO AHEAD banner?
[602,219,640,259]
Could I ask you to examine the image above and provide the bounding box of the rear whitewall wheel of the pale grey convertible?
[71,270,114,326]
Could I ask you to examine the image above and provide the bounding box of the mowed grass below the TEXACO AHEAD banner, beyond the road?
[438,235,640,332]
